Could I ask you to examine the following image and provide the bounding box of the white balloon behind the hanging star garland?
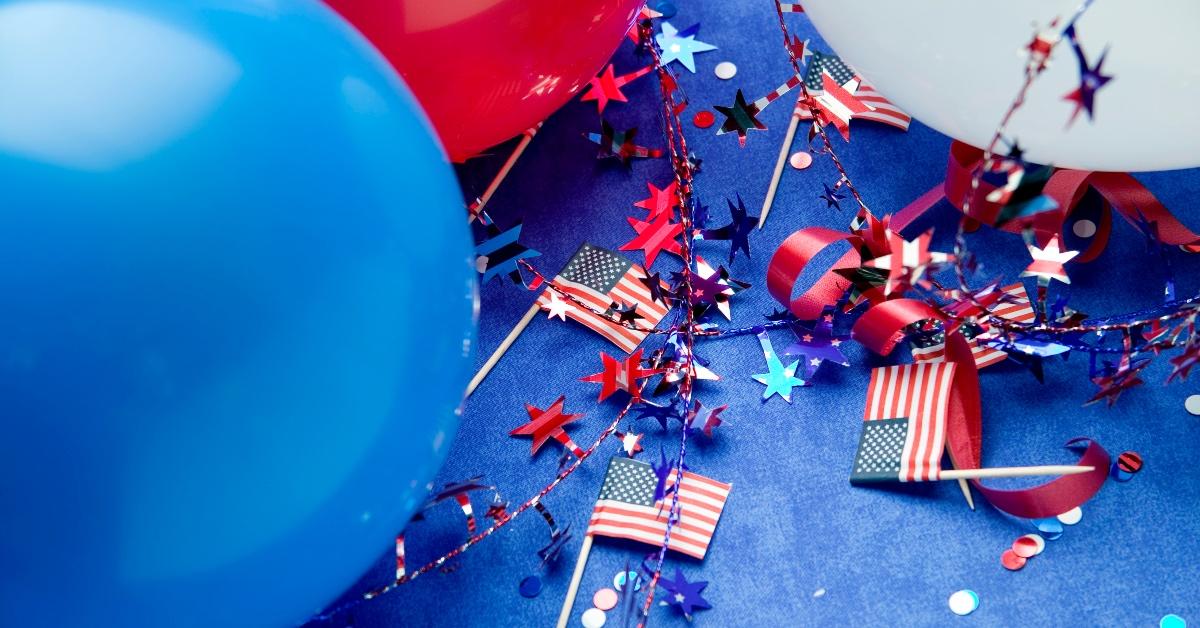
[804,0,1200,171]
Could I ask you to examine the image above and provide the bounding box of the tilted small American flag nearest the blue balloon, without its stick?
[538,244,670,353]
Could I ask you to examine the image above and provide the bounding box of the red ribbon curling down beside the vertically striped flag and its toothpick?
[851,299,1110,519]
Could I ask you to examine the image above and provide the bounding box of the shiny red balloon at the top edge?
[326,0,642,161]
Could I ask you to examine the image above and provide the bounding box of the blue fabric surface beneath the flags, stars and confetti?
[312,1,1200,626]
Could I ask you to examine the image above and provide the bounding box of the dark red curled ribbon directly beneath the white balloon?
[892,142,1200,262]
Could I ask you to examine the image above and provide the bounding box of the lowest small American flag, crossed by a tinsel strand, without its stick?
[587,456,733,558]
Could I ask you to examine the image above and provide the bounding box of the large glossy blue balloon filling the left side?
[0,0,475,628]
